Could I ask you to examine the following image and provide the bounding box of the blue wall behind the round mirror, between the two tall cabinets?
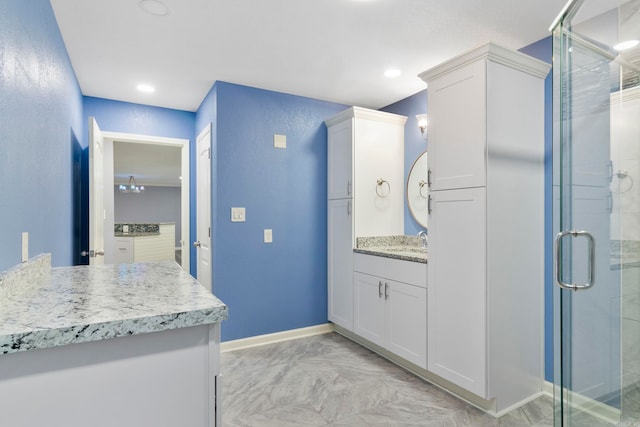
[380,89,427,235]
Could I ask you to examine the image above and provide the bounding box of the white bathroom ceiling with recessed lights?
[51,0,566,111]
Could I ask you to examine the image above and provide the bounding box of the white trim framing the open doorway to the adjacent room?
[102,131,191,272]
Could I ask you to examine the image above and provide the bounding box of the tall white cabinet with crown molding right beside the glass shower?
[421,43,549,411]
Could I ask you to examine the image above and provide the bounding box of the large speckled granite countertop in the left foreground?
[0,261,228,354]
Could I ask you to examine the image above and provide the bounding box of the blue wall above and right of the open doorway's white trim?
[83,96,196,274]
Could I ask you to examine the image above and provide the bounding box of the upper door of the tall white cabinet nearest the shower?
[427,60,487,190]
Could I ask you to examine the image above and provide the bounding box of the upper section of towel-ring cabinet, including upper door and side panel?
[325,107,407,237]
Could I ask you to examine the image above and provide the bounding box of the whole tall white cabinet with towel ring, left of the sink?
[325,107,407,331]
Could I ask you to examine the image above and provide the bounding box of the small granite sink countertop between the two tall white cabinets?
[353,236,427,264]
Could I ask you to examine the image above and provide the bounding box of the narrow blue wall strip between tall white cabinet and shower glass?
[520,37,554,381]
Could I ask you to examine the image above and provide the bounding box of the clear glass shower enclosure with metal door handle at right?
[552,0,640,426]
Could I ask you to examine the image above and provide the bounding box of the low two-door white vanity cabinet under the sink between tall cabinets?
[354,254,427,369]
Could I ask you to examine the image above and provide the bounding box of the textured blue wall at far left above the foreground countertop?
[0,0,84,270]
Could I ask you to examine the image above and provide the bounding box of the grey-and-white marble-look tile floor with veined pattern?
[220,333,553,427]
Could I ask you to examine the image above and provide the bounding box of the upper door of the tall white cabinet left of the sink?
[327,120,353,199]
